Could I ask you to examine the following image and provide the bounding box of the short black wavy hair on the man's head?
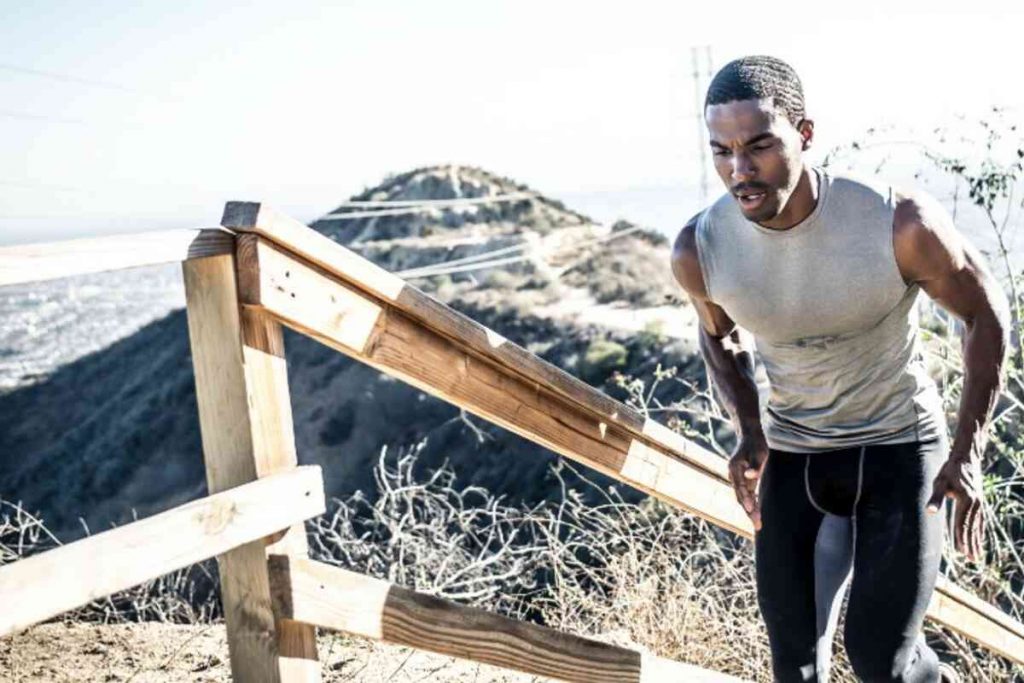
[705,54,805,126]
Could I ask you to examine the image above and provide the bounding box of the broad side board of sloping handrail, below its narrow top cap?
[238,236,752,535]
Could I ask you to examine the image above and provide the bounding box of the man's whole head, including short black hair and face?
[705,56,814,223]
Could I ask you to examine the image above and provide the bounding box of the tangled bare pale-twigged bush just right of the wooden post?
[307,442,541,614]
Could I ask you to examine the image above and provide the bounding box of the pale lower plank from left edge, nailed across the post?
[0,467,324,636]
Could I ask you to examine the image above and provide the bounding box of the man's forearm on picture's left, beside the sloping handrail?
[697,327,764,441]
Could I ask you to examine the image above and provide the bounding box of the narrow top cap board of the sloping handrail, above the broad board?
[221,202,729,482]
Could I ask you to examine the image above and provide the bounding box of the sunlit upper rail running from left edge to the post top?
[0,228,234,287]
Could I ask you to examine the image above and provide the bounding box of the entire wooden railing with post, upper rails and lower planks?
[0,203,1024,683]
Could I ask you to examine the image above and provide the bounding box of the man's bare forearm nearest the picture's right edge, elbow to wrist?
[949,315,1009,460]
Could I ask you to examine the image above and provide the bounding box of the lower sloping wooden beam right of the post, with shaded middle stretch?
[269,556,738,683]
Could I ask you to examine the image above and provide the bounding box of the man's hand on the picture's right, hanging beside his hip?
[928,455,985,561]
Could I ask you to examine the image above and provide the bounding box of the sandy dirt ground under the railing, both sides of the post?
[0,623,549,683]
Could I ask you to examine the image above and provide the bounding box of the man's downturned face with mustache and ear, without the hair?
[705,99,813,223]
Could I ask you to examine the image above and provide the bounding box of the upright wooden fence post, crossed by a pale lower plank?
[182,254,319,683]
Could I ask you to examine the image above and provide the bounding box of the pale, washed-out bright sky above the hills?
[0,0,1024,244]
